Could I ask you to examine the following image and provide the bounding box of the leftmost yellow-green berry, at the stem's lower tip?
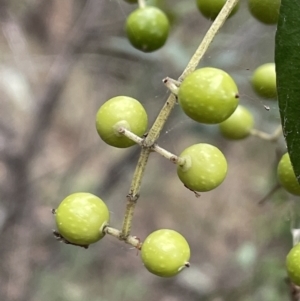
[55,192,109,245]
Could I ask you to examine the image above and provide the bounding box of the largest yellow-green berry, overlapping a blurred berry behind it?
[178,67,239,124]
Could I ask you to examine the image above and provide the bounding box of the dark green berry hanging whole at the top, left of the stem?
[126,6,170,52]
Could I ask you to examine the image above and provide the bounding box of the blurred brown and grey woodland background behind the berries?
[0,0,297,301]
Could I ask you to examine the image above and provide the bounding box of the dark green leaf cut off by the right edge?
[275,0,300,183]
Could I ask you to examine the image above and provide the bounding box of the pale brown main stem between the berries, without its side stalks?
[121,0,239,240]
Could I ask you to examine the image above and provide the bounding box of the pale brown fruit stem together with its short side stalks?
[103,0,239,249]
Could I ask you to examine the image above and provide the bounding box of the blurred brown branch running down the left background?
[0,0,101,301]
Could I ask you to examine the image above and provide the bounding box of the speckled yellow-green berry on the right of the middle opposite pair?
[177,143,227,192]
